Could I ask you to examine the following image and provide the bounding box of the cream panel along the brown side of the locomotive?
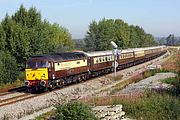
[55,59,87,71]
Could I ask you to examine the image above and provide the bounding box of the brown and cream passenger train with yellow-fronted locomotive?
[25,46,167,91]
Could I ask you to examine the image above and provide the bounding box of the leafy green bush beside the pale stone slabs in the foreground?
[56,102,98,120]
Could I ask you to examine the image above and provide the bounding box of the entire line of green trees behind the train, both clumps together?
[0,5,155,83]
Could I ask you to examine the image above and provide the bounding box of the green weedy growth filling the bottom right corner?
[122,93,180,120]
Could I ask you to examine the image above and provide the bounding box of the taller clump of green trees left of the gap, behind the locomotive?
[0,5,74,83]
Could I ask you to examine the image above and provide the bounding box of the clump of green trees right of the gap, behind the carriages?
[84,18,155,51]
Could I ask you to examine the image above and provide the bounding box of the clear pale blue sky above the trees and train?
[0,0,180,39]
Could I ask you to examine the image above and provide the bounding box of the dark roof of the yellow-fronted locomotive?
[32,52,86,61]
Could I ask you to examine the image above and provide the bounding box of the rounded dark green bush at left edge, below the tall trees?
[0,51,19,84]
